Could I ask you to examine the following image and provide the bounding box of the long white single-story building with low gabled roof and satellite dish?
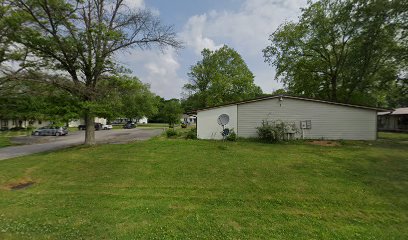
[197,95,387,140]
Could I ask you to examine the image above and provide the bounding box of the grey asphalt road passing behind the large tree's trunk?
[0,128,163,160]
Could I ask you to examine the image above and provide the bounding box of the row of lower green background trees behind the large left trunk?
[0,75,158,123]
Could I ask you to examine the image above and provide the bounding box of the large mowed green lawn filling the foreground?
[0,139,408,239]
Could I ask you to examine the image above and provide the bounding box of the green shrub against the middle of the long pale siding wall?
[256,121,297,143]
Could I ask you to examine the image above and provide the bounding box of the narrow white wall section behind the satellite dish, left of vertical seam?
[197,105,237,139]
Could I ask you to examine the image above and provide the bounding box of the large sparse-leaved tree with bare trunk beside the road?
[10,0,181,145]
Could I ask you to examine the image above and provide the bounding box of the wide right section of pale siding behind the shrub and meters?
[237,97,377,140]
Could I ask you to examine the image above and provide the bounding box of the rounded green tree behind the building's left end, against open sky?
[183,45,262,110]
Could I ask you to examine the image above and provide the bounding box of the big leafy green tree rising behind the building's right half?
[263,0,406,105]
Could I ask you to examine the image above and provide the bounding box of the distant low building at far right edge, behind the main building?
[377,107,408,132]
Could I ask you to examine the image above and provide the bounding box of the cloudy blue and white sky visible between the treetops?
[117,0,307,99]
